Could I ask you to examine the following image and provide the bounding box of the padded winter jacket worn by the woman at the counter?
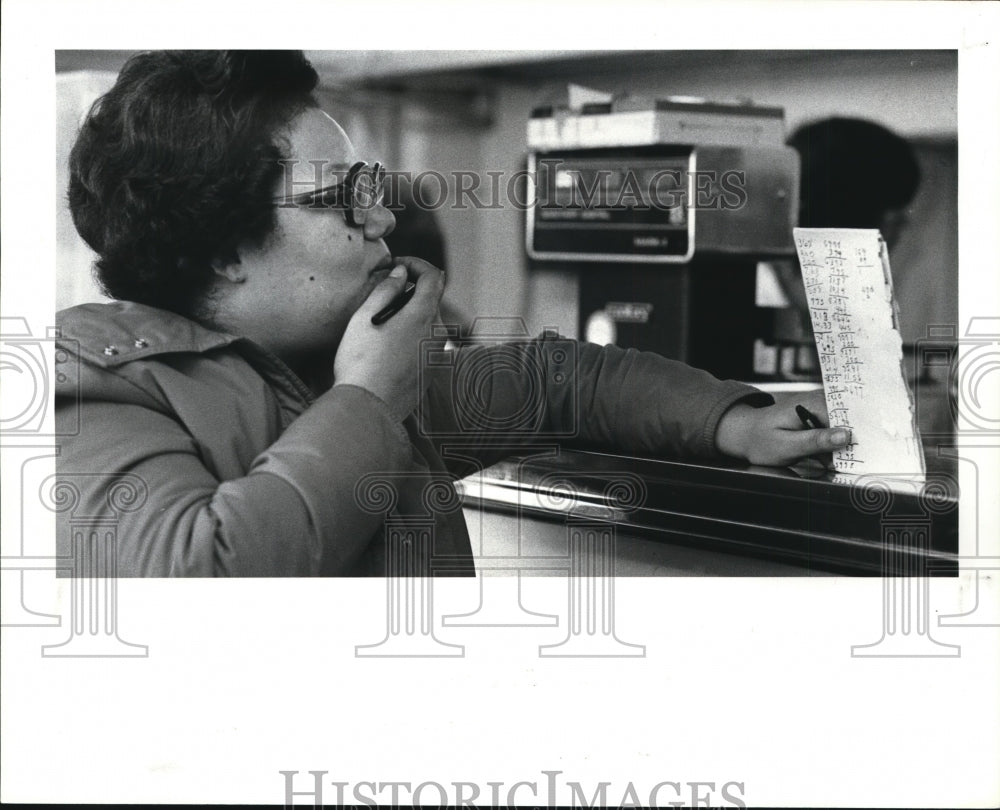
[56,302,771,577]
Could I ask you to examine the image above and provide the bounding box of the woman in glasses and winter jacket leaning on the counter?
[57,52,848,576]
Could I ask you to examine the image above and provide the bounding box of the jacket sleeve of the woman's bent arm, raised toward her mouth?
[57,385,412,577]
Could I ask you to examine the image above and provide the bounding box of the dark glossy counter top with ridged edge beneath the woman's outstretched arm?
[460,450,958,576]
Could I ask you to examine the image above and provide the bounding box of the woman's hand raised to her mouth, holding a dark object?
[333,256,444,420]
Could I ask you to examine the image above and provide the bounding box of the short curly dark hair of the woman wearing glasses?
[69,51,318,314]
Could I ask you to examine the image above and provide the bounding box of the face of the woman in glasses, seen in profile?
[220,109,395,361]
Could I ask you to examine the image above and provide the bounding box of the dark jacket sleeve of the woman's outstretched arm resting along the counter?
[425,336,773,468]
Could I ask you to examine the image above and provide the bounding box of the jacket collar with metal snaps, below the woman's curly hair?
[56,301,239,368]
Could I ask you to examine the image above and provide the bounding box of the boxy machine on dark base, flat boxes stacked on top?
[526,100,819,381]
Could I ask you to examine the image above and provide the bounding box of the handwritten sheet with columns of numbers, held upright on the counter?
[795,228,925,479]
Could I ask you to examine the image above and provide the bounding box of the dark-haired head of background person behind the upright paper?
[788,118,920,247]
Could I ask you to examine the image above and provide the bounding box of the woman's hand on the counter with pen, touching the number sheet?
[715,390,851,467]
